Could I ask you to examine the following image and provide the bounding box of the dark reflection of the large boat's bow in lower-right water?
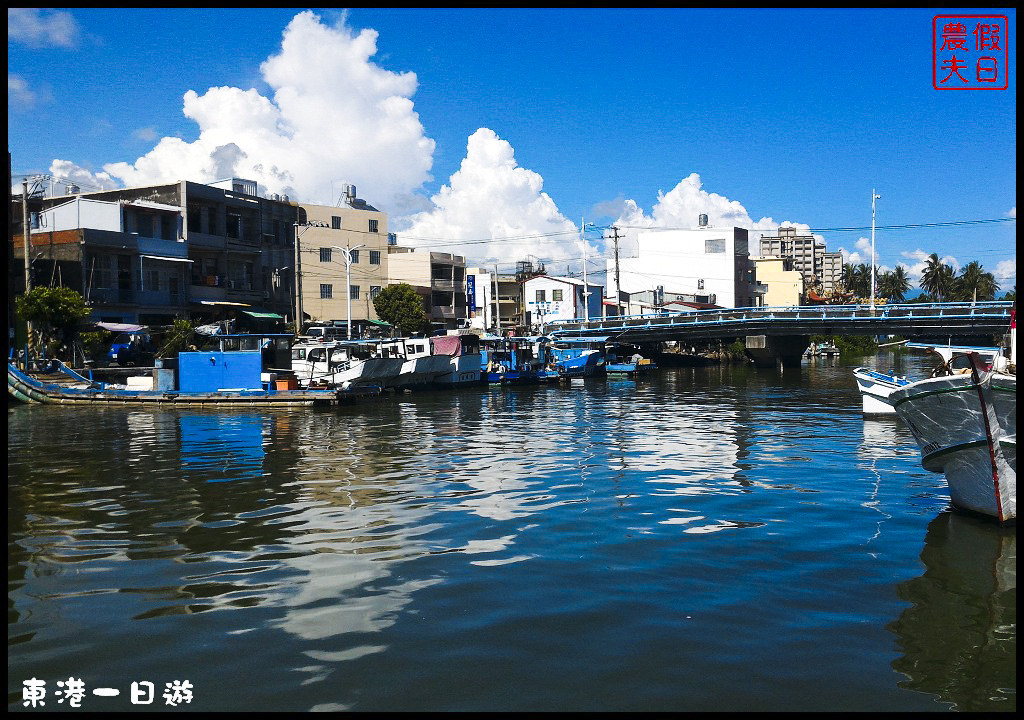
[888,512,1017,712]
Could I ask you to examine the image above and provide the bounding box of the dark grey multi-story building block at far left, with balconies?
[12,178,296,325]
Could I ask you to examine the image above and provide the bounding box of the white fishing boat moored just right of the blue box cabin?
[292,340,406,389]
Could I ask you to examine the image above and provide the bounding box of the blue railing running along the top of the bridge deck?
[547,300,1014,334]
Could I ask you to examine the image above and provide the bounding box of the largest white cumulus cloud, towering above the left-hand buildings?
[56,10,434,212]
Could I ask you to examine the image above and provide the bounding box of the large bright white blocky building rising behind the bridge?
[607,225,756,307]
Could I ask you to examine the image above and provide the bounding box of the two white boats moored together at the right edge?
[854,313,1017,522]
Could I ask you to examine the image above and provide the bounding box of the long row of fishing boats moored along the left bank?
[7,333,654,407]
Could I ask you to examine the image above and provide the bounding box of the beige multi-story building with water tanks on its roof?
[293,185,394,337]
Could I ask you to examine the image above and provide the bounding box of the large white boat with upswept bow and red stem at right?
[888,354,1017,522]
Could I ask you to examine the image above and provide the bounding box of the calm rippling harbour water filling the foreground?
[7,354,1017,712]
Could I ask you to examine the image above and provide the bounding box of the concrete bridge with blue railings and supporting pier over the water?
[545,300,1014,367]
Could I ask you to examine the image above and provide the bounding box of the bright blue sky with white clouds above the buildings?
[7,8,1017,290]
